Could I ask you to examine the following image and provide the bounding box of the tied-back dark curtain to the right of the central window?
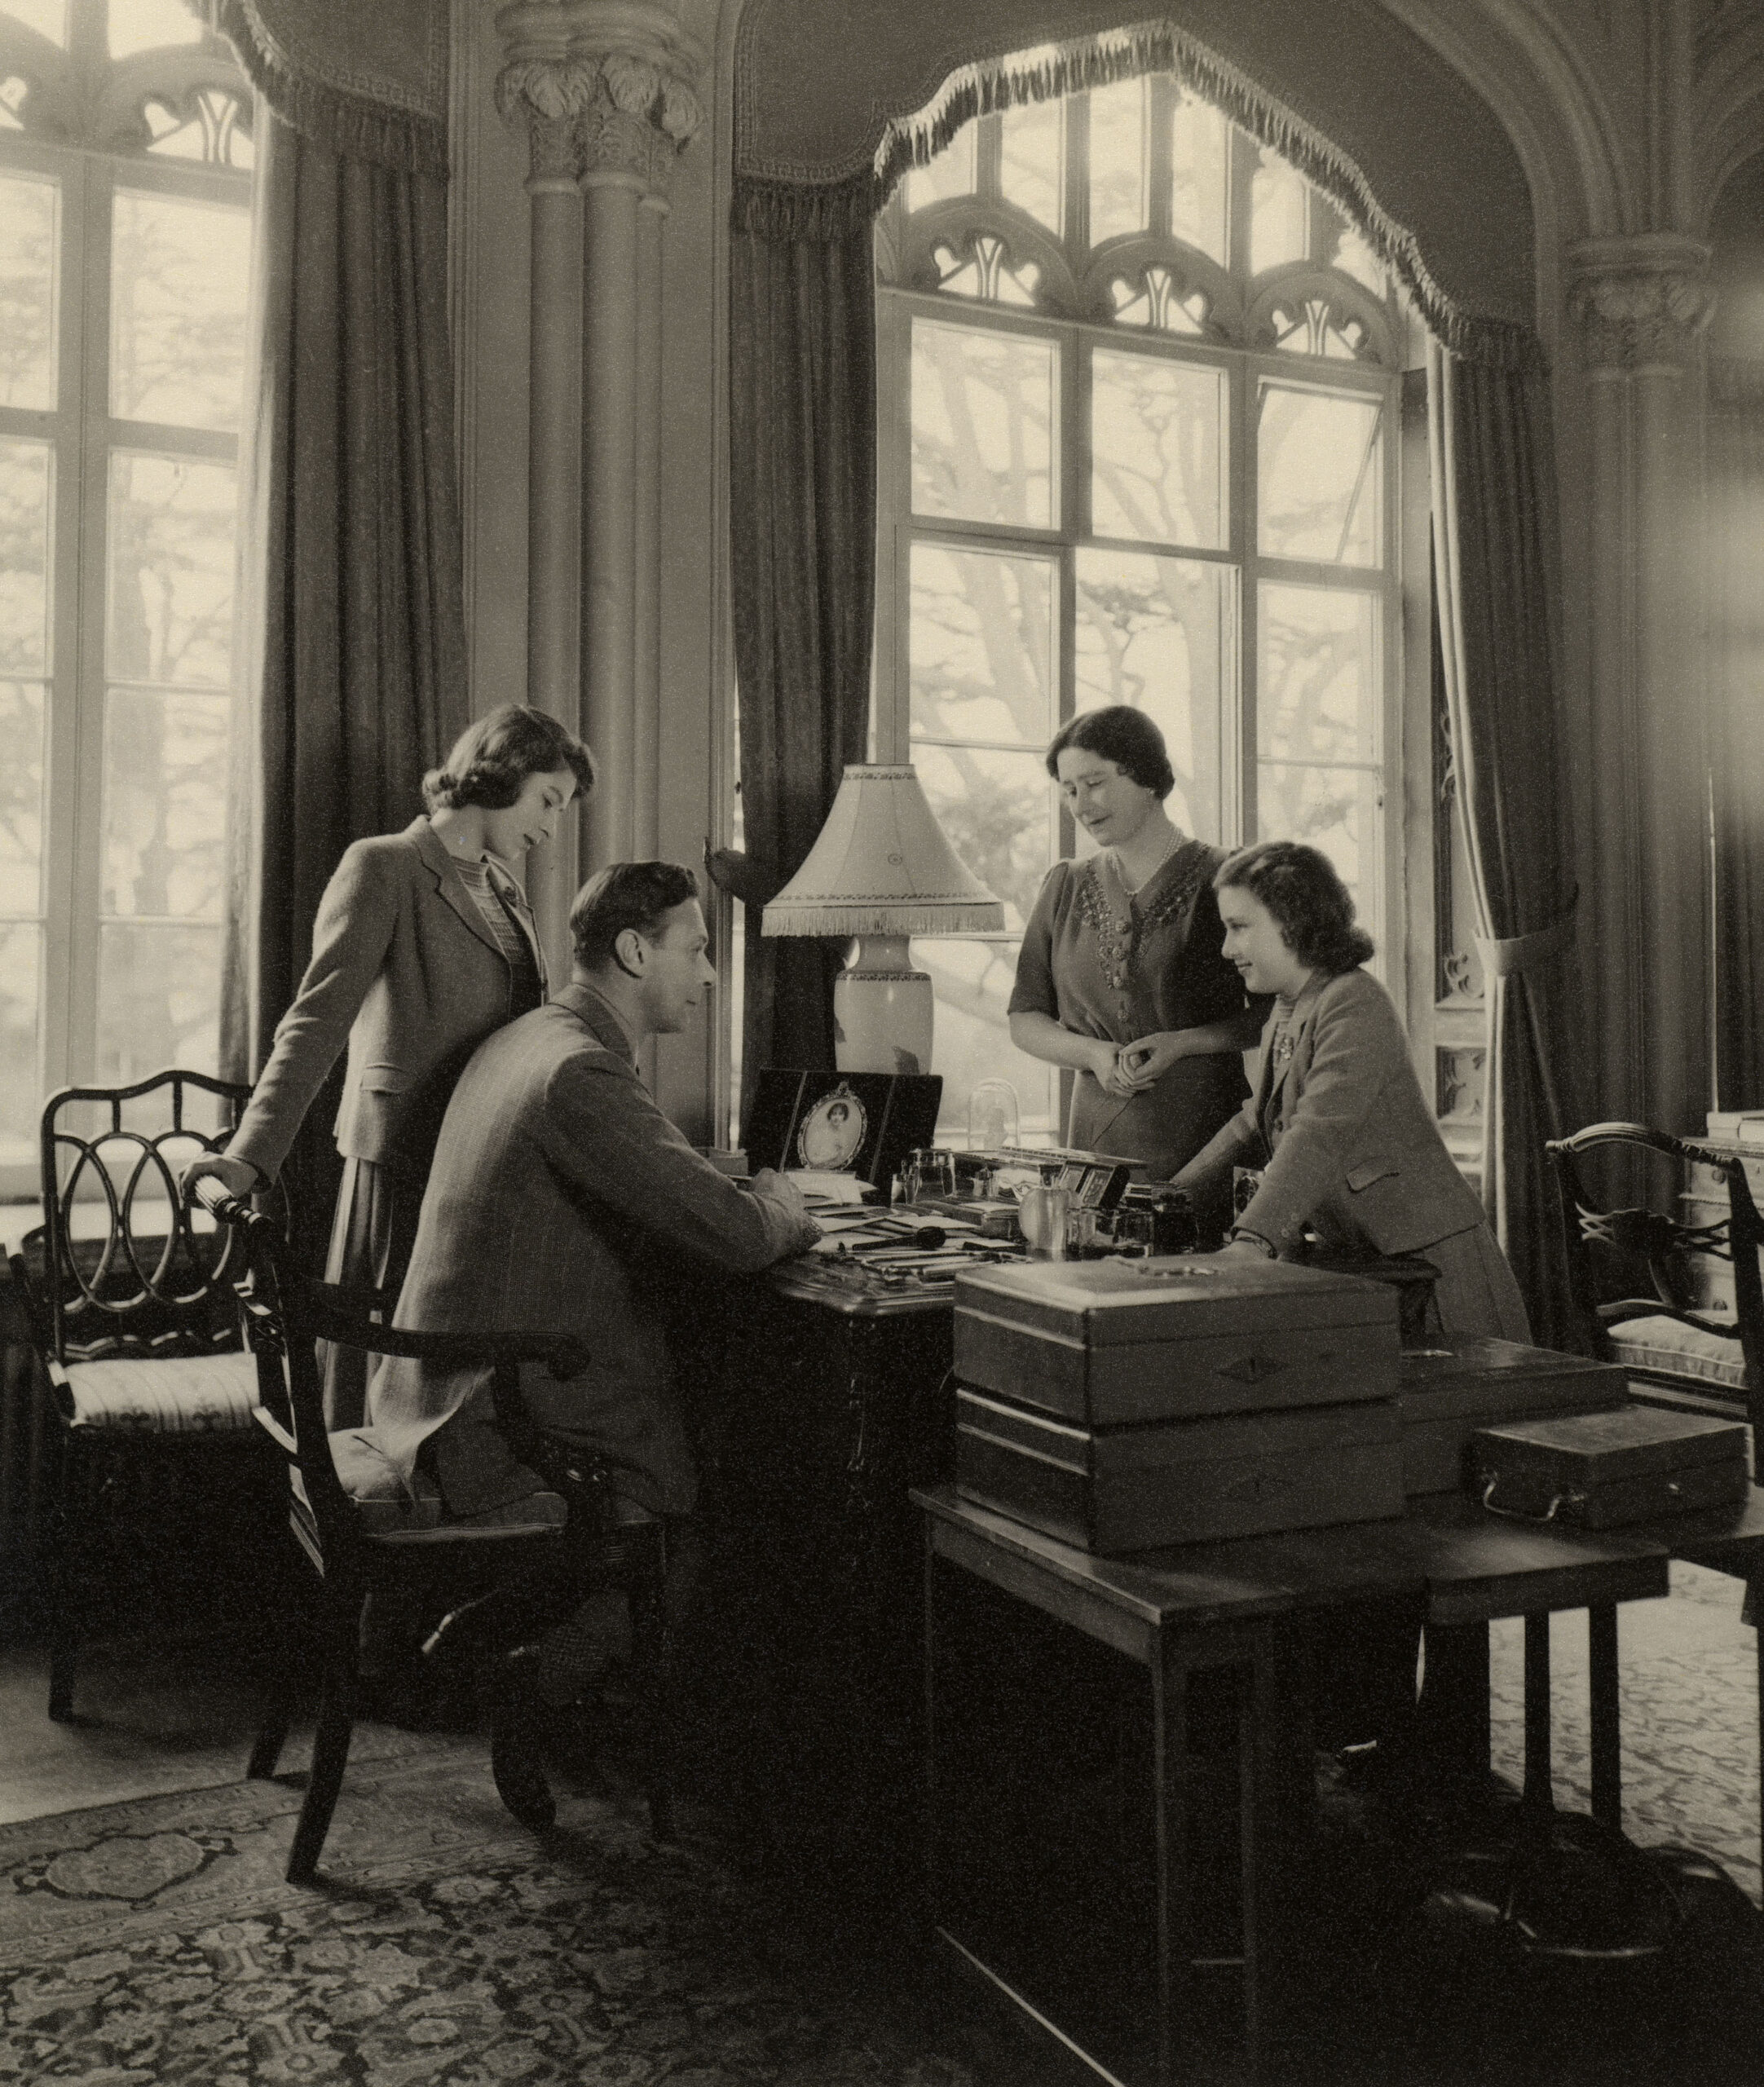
[1428,342,1586,1348]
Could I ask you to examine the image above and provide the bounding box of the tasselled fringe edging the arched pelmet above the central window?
[733,19,1538,369]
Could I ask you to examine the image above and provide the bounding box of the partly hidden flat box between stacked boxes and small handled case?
[1396,1335,1629,1492]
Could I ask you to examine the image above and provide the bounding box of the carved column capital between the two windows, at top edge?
[497,0,706,201]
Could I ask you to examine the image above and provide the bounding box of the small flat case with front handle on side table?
[1474,1406,1752,1529]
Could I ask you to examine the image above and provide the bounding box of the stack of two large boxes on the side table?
[954,1255,1403,1555]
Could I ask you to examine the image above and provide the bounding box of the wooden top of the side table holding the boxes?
[912,1486,1736,1628]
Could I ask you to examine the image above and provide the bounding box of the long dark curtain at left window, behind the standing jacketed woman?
[219,4,468,1240]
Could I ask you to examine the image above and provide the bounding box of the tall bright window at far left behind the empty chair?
[0,0,253,1192]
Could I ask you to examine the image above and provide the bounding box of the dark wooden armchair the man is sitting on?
[196,1181,673,1885]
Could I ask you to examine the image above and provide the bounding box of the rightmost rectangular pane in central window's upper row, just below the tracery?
[1257,384,1384,566]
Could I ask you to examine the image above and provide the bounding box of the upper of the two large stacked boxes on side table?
[954,1255,1399,1427]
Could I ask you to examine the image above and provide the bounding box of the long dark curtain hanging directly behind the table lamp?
[729,198,877,1089]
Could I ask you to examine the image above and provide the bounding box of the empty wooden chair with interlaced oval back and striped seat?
[12,1070,276,1722]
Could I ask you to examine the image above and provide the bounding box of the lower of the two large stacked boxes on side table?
[956,1386,1403,1555]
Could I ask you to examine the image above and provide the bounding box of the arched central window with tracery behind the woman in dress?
[875,75,1426,1132]
